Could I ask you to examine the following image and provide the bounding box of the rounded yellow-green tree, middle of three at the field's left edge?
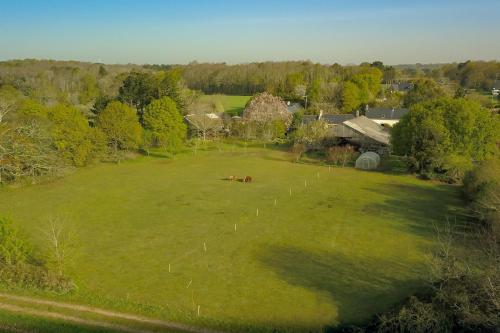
[97,101,142,154]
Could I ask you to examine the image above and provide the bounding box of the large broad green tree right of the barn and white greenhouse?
[391,98,500,180]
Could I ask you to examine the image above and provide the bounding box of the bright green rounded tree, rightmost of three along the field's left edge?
[143,97,187,152]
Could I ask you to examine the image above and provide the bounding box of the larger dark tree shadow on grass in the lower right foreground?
[258,246,425,331]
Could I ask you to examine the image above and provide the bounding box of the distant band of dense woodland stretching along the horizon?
[0,60,500,114]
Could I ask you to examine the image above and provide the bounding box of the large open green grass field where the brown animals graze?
[0,148,460,331]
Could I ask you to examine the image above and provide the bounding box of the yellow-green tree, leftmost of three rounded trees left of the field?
[48,104,96,166]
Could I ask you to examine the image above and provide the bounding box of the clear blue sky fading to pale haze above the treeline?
[0,0,500,64]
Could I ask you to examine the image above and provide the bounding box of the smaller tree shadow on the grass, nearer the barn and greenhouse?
[362,184,466,237]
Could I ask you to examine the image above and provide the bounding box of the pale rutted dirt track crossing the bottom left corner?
[0,293,225,333]
